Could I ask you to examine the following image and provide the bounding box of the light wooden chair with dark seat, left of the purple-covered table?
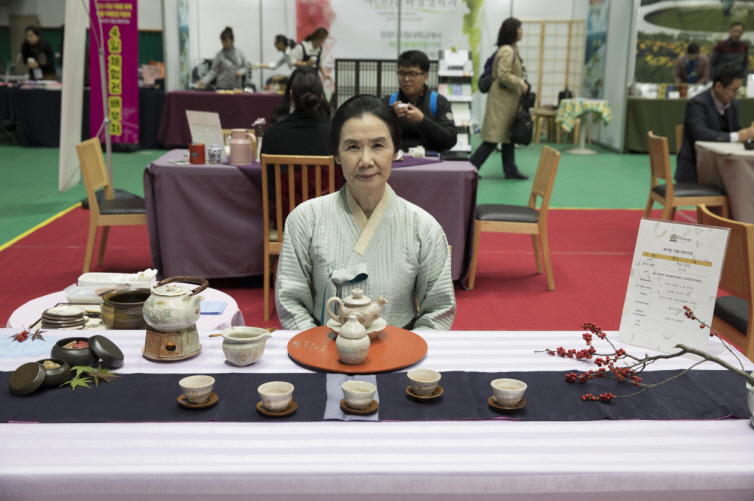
[76,138,147,273]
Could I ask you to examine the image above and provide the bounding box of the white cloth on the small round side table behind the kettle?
[6,285,246,331]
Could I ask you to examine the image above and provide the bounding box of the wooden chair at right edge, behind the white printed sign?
[696,204,754,360]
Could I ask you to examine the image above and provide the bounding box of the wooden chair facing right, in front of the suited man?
[644,131,728,221]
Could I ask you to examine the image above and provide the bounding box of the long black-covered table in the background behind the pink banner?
[0,86,165,149]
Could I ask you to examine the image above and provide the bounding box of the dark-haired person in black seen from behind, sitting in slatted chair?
[262,69,340,226]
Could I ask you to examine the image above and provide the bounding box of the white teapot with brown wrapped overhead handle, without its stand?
[144,277,209,332]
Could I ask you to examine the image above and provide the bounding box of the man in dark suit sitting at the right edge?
[675,65,754,183]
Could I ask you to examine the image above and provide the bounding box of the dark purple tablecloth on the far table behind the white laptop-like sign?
[157,91,283,148]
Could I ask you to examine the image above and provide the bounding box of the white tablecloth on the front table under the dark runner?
[0,331,754,501]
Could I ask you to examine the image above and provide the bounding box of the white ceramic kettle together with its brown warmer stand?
[142,277,209,361]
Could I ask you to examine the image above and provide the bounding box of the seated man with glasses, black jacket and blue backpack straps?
[382,50,457,151]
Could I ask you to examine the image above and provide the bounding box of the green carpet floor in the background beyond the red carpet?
[0,135,675,245]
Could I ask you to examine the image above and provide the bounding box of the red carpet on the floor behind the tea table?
[0,205,694,330]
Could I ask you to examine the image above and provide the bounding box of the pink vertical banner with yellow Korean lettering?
[89,0,139,143]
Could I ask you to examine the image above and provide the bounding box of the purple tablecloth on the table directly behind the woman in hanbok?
[144,150,477,280]
